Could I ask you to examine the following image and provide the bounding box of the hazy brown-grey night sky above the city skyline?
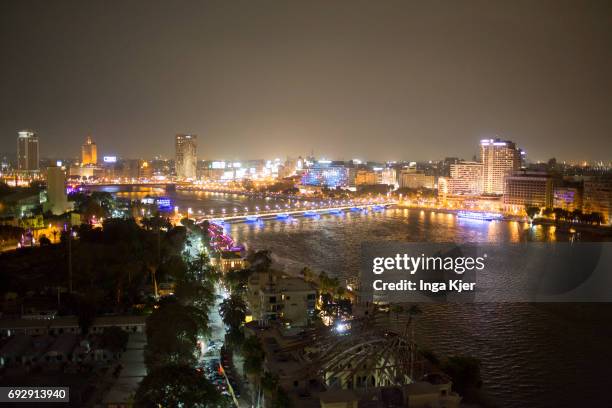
[0,0,612,161]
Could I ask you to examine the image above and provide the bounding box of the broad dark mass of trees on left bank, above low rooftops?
[0,218,180,314]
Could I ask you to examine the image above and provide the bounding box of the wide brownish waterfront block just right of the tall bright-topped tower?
[503,170,553,213]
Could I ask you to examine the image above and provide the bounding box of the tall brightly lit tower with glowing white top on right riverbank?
[480,139,521,195]
